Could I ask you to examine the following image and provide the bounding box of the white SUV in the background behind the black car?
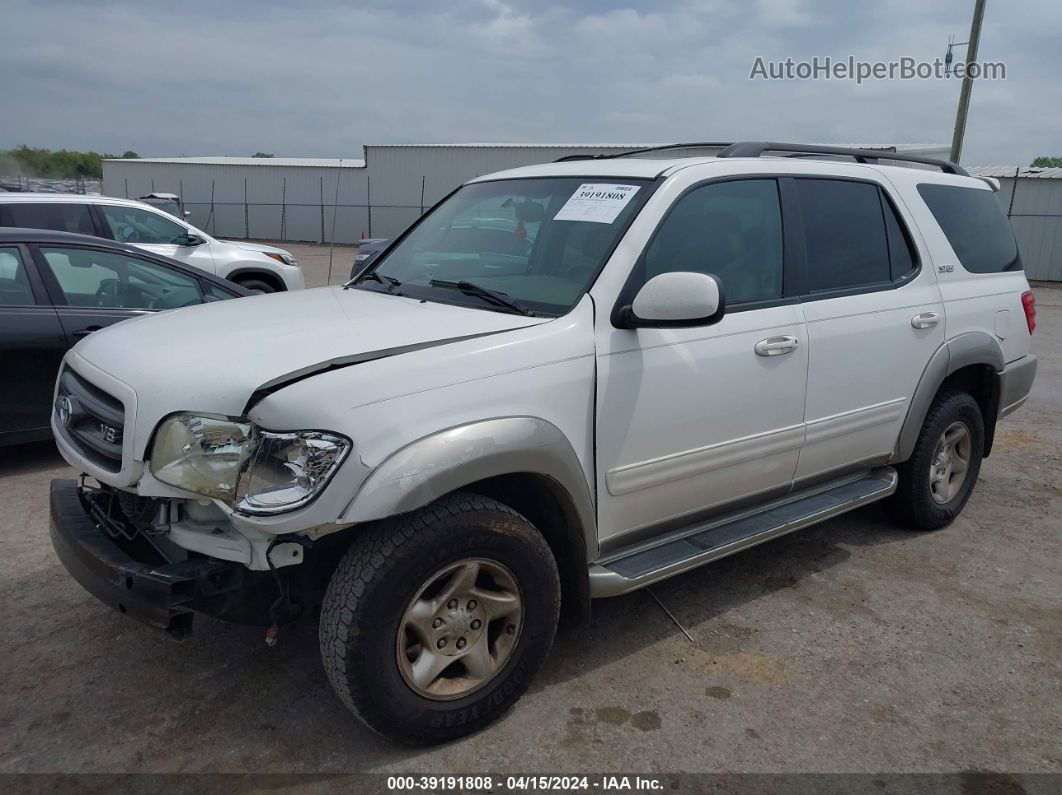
[0,193,305,293]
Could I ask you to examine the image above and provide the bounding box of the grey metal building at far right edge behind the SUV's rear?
[967,166,1062,281]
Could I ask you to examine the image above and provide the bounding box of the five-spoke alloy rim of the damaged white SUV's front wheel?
[395,558,524,701]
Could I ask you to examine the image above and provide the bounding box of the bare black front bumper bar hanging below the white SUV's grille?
[51,480,245,639]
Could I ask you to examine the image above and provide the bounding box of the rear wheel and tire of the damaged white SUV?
[889,391,984,530]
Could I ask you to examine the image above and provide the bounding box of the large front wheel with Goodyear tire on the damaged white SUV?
[320,492,561,745]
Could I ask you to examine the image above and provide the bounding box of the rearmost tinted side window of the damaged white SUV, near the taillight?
[919,183,1022,273]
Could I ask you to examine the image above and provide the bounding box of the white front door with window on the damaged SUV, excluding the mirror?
[596,178,808,551]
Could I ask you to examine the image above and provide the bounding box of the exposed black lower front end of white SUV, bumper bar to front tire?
[51,480,339,640]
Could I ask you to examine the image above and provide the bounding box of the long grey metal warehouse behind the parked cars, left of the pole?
[103,143,947,243]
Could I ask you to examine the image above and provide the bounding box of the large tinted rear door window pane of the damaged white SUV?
[795,178,892,293]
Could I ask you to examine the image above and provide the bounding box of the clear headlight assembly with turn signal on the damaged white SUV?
[151,414,350,514]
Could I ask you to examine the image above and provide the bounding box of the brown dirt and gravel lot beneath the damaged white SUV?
[0,273,1062,774]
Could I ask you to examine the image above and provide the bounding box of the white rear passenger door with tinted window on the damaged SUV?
[782,177,944,481]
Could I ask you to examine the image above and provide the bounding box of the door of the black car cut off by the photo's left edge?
[0,245,67,444]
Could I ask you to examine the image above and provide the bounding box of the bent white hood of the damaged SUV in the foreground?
[71,287,547,443]
